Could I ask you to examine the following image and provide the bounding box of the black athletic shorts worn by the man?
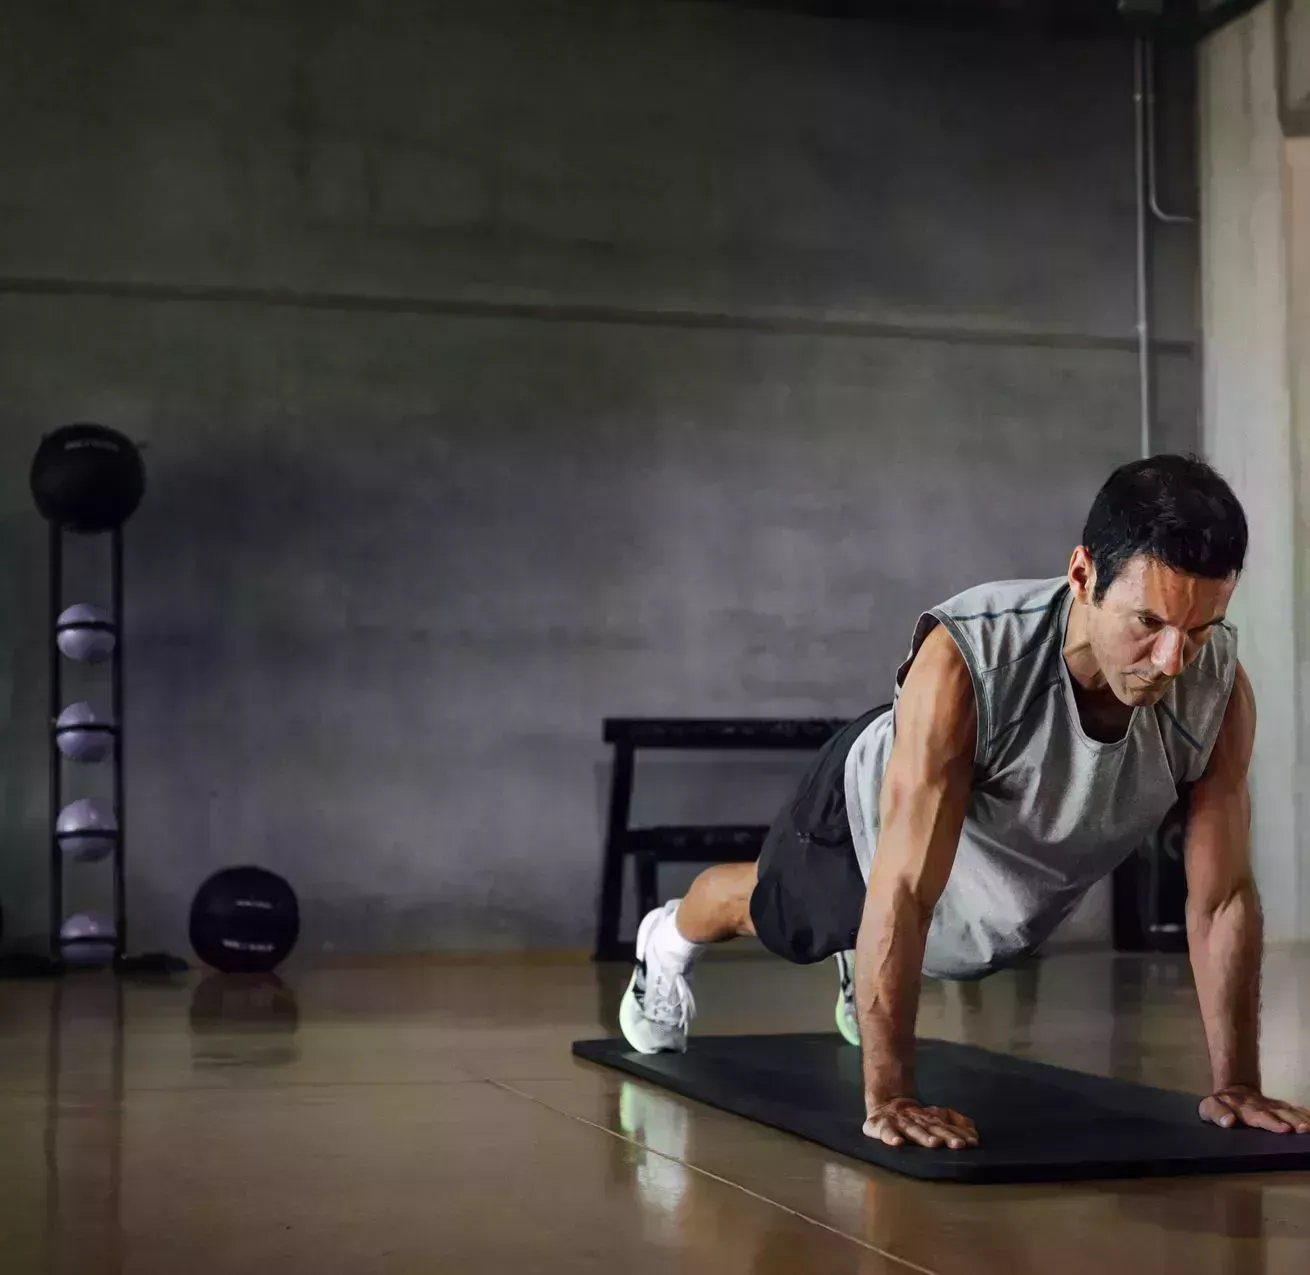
[751,704,891,964]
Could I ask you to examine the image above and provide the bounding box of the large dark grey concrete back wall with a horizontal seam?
[0,0,1197,950]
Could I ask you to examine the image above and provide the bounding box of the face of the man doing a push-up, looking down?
[1070,549,1237,705]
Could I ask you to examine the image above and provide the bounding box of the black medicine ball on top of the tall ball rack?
[31,425,145,532]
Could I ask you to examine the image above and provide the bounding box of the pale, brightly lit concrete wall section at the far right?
[1200,3,1310,940]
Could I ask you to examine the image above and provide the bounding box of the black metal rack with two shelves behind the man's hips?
[595,717,848,961]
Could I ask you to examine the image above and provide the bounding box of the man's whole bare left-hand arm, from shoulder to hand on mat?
[855,628,977,1145]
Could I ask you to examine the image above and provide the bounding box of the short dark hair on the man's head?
[1082,455,1247,604]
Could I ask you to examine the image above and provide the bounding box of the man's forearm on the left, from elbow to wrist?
[855,888,931,1109]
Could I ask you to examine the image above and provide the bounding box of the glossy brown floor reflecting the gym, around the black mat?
[0,951,1310,1275]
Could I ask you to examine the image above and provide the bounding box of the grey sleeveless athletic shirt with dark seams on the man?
[846,577,1237,979]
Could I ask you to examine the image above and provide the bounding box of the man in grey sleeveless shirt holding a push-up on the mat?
[621,456,1310,1149]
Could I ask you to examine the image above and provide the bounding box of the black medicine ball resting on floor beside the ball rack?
[191,867,300,974]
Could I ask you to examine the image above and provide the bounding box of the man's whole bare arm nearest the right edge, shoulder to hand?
[1184,666,1310,1133]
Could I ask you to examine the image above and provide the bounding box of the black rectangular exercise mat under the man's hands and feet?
[574,1034,1310,1182]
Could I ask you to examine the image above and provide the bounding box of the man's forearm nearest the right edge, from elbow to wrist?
[1187,881,1264,1092]
